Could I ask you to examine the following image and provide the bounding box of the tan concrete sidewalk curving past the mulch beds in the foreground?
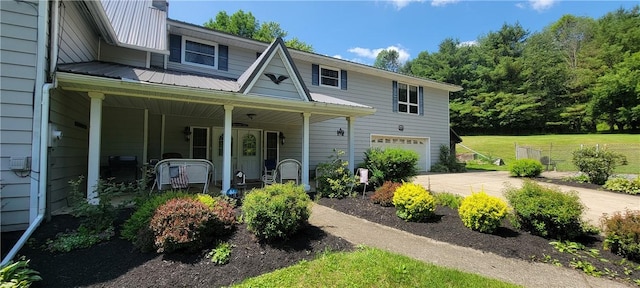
[309,204,629,287]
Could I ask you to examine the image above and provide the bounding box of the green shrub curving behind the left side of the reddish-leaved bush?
[120,191,192,245]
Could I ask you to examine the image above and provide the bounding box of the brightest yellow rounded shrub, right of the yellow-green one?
[458,191,508,233]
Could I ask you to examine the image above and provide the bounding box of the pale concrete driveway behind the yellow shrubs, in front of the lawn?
[414,171,640,226]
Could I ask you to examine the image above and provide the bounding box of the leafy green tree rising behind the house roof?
[203,10,313,52]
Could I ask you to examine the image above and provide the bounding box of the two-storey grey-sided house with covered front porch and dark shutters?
[0,0,462,264]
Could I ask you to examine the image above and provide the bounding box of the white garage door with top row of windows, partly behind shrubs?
[371,135,431,171]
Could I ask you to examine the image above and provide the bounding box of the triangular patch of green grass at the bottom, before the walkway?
[234,247,519,287]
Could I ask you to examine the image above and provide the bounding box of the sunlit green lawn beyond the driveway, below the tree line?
[456,134,640,174]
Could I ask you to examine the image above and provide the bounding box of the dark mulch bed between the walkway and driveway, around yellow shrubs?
[319,192,640,280]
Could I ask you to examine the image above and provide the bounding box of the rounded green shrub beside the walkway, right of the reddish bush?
[242,183,311,241]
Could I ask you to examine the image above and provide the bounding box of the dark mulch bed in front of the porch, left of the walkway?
[2,211,353,287]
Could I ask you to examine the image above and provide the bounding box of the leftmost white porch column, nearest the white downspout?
[87,92,104,204]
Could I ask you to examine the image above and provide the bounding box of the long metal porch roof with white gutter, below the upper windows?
[56,61,376,117]
